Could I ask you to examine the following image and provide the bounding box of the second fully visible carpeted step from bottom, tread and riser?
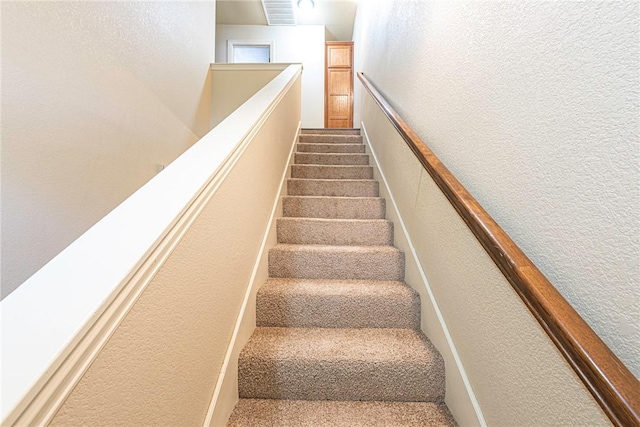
[256,278,420,330]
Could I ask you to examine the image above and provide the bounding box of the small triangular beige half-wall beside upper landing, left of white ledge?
[211,64,287,128]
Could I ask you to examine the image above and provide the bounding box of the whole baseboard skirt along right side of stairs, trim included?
[360,122,487,427]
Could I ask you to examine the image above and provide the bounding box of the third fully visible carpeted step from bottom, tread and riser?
[269,243,404,280]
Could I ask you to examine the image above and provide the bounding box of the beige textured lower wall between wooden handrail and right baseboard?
[362,97,609,426]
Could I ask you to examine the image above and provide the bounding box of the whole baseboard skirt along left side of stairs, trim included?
[203,123,301,427]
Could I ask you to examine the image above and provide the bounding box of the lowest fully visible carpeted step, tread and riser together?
[238,327,445,402]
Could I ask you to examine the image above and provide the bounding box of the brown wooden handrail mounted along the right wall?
[358,72,640,426]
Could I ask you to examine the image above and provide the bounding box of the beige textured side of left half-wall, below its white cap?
[52,79,300,426]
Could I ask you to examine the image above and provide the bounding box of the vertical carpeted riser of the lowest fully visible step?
[238,357,445,402]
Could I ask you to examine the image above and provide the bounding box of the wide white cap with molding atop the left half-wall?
[0,66,301,426]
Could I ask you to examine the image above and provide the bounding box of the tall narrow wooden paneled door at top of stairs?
[324,42,353,128]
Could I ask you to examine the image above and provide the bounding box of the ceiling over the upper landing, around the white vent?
[216,0,358,41]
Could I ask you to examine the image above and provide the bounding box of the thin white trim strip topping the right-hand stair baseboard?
[360,122,487,427]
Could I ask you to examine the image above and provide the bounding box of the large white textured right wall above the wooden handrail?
[354,0,640,377]
